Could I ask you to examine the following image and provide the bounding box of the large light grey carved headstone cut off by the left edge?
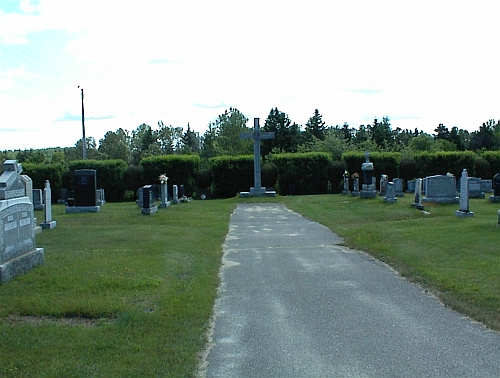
[0,160,45,283]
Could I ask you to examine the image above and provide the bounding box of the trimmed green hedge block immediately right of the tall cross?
[272,152,332,195]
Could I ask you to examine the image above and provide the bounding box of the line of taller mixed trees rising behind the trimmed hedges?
[0,108,500,166]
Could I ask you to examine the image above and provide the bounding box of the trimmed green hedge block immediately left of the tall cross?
[209,155,254,198]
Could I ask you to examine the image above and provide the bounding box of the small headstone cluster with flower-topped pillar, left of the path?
[136,182,187,215]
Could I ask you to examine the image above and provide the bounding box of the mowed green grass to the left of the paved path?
[0,201,235,377]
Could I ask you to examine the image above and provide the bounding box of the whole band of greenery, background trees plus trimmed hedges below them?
[0,108,500,201]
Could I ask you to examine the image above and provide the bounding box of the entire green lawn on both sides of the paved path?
[0,195,500,377]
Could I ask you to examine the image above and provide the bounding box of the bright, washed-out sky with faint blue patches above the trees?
[0,0,500,150]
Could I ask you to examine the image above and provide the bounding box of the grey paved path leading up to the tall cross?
[201,204,500,378]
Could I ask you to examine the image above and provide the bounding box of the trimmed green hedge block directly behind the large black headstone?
[69,159,127,202]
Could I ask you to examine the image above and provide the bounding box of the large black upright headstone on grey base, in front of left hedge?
[66,169,101,213]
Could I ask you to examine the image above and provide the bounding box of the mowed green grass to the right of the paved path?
[284,194,500,331]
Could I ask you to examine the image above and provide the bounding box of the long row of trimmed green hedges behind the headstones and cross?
[12,151,500,202]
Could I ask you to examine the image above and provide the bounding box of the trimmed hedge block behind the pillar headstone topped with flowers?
[140,155,200,196]
